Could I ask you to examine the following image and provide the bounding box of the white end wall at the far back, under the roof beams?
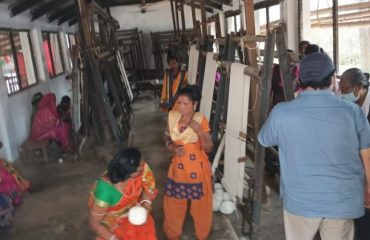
[111,1,201,69]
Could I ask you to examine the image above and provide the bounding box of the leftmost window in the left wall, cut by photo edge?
[0,30,37,94]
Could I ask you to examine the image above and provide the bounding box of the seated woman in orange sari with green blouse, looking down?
[89,148,158,240]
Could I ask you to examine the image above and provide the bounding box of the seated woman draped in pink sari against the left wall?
[31,93,72,151]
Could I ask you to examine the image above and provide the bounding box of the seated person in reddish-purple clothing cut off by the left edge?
[0,141,30,227]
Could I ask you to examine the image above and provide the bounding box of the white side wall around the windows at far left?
[0,3,76,161]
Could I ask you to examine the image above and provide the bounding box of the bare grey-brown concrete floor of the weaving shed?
[0,94,284,240]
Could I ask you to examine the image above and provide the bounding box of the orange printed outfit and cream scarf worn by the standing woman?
[164,111,213,239]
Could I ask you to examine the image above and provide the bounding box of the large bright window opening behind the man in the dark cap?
[303,0,370,74]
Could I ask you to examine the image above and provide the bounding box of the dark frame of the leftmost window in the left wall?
[0,28,40,96]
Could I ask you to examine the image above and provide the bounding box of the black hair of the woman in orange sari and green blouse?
[108,148,141,184]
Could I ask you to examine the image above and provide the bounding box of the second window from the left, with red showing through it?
[42,32,64,77]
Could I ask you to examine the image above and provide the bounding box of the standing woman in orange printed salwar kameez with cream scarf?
[164,86,213,240]
